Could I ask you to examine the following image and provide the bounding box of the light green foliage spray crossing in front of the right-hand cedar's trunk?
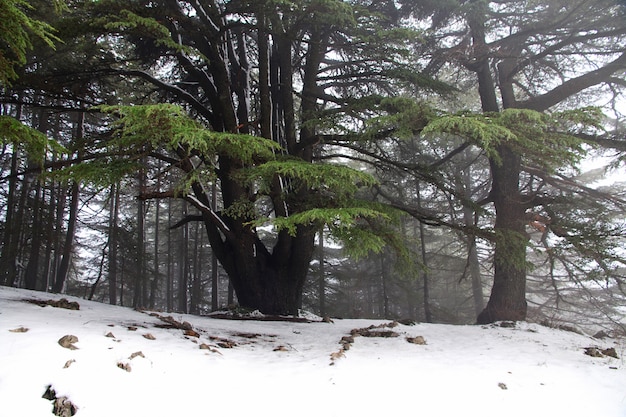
[423,108,588,171]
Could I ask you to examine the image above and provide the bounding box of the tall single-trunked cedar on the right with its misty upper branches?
[404,1,626,323]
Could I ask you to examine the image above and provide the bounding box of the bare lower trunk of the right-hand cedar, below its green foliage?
[477,145,527,324]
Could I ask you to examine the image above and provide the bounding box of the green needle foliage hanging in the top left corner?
[0,0,62,85]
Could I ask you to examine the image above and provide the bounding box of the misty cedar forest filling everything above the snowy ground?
[0,0,626,333]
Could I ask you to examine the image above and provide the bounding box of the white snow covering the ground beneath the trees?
[0,287,626,417]
